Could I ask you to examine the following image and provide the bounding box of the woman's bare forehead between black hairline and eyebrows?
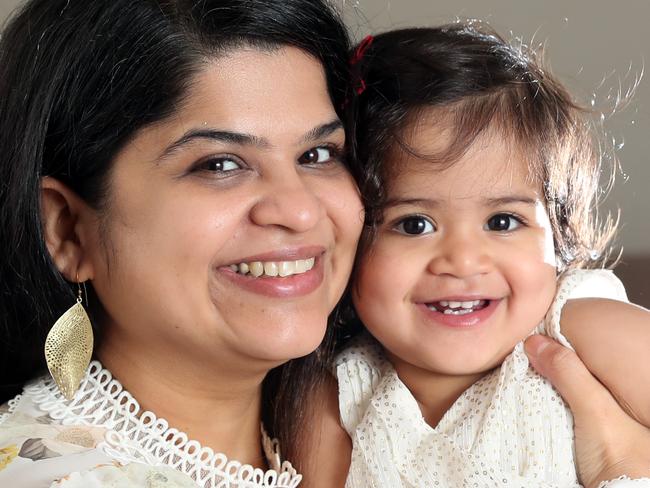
[131,47,344,153]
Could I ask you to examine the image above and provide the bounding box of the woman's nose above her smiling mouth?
[250,170,323,232]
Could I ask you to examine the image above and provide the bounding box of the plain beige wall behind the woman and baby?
[0,0,650,306]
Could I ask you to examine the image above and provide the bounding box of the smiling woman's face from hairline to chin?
[83,47,362,367]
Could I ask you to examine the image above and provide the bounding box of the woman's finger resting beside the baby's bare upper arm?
[524,335,614,416]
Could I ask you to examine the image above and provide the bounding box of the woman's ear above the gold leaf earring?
[41,176,95,283]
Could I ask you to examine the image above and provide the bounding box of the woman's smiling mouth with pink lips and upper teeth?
[218,250,324,298]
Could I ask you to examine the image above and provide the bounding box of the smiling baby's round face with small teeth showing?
[353,122,556,376]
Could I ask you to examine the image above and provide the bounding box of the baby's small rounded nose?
[428,233,492,278]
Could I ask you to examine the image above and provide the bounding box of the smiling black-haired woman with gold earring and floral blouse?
[0,0,362,487]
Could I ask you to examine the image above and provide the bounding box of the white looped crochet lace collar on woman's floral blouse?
[24,361,302,488]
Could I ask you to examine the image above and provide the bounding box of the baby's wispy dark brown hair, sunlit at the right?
[351,22,616,270]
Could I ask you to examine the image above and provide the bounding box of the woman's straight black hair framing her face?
[0,0,349,468]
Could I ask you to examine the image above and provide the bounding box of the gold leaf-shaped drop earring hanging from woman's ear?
[45,276,93,400]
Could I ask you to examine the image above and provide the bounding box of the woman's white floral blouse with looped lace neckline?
[0,361,302,488]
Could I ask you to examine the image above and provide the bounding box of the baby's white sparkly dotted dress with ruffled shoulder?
[335,271,650,488]
